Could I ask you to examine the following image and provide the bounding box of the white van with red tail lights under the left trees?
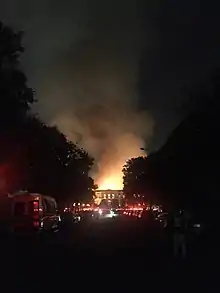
[11,192,60,231]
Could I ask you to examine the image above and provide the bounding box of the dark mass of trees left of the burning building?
[0,23,94,201]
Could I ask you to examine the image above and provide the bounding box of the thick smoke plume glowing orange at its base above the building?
[0,0,153,188]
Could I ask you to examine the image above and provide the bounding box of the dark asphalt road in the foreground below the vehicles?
[1,217,219,292]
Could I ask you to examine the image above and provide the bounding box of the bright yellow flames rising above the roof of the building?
[98,172,123,190]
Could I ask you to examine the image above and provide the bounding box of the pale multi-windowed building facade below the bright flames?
[94,189,125,206]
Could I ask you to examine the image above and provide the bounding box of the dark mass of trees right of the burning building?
[123,70,220,219]
